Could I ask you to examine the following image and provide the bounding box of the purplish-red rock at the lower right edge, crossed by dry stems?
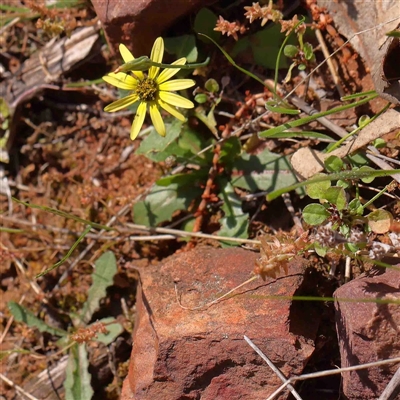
[334,269,400,400]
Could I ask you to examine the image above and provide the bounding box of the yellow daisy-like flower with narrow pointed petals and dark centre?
[103,37,195,140]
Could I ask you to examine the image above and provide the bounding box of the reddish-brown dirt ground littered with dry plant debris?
[0,1,400,400]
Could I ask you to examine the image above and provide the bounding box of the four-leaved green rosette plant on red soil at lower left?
[8,251,123,400]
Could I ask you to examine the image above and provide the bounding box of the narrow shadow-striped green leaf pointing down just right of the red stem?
[218,179,249,246]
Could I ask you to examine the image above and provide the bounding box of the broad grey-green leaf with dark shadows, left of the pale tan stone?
[231,150,297,192]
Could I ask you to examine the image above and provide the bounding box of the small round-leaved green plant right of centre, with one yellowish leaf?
[303,156,396,260]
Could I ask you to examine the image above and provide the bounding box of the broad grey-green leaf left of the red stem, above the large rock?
[133,183,202,226]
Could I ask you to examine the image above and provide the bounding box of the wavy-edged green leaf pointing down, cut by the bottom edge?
[64,344,94,400]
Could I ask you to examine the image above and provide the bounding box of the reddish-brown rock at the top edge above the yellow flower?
[92,0,215,57]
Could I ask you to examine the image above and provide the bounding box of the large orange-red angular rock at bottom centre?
[121,248,319,400]
